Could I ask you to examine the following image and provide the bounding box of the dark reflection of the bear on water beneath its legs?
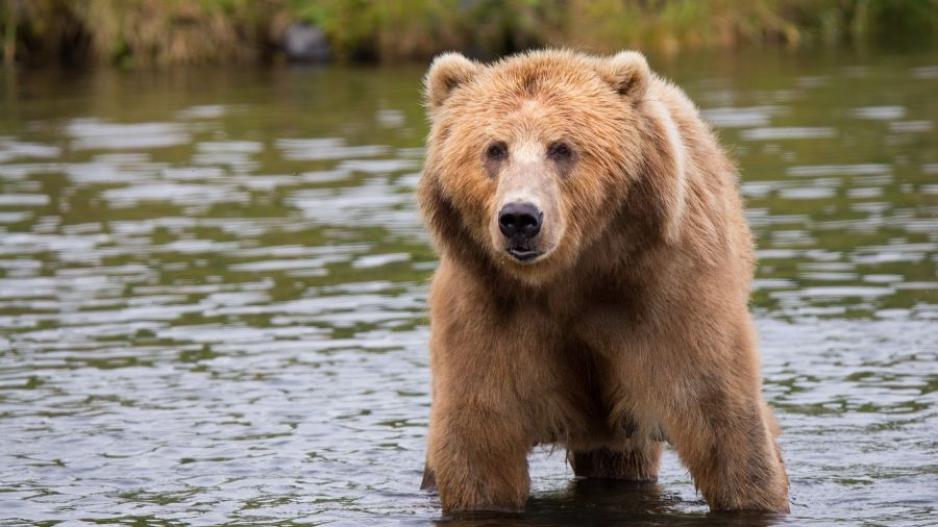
[435,479,784,527]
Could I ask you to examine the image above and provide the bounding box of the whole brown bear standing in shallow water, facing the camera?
[418,51,788,513]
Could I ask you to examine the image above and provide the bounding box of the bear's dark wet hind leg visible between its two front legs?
[567,440,661,482]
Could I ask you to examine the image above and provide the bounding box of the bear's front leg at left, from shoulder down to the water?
[427,260,556,513]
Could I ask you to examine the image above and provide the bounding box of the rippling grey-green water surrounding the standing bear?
[0,48,938,525]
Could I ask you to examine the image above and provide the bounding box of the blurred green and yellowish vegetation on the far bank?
[0,0,938,67]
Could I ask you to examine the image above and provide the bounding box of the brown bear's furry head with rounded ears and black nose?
[418,51,673,284]
